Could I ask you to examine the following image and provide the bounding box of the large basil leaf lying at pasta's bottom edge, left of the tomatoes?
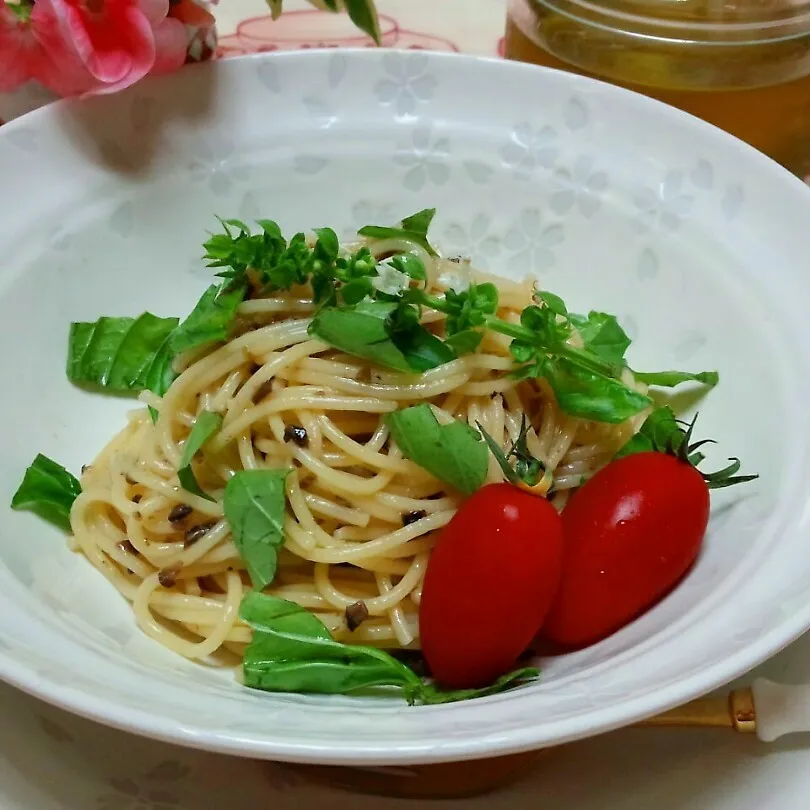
[239,592,423,700]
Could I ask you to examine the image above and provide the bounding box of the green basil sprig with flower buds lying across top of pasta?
[196,209,718,424]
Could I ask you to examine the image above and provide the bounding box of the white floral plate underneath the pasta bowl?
[0,635,810,810]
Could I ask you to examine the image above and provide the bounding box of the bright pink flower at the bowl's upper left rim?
[0,0,186,96]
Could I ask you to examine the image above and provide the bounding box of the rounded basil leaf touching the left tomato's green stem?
[386,404,489,495]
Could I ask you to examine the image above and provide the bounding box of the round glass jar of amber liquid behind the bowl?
[506,0,810,177]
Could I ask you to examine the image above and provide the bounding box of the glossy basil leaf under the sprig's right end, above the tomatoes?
[540,358,652,424]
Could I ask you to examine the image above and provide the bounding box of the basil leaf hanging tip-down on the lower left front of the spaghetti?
[223,470,290,591]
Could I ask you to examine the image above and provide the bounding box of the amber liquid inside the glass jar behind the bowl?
[506,0,810,177]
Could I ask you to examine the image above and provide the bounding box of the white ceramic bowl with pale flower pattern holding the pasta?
[0,51,810,764]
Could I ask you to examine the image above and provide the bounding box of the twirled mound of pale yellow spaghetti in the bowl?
[71,249,644,658]
